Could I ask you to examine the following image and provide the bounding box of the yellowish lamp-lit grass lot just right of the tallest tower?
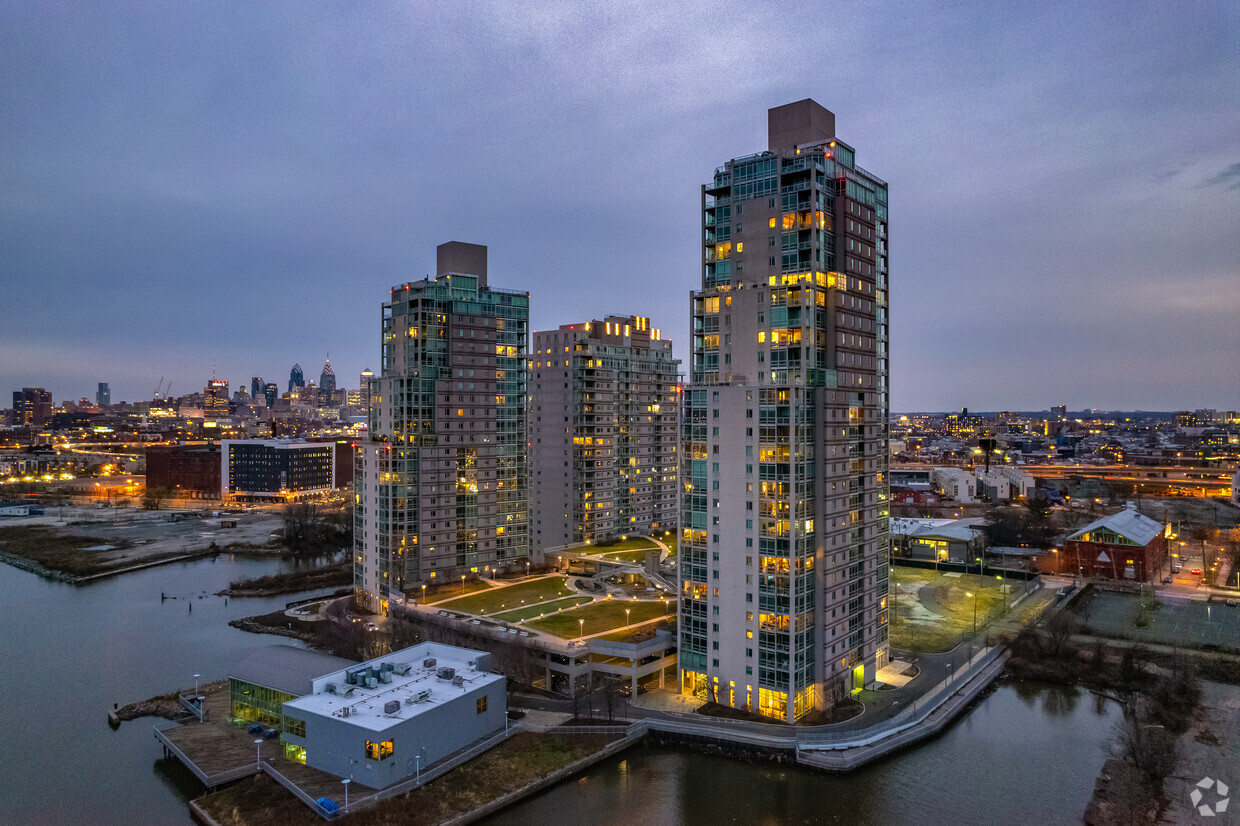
[890,566,1019,654]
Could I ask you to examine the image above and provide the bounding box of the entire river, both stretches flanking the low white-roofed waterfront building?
[0,556,1118,826]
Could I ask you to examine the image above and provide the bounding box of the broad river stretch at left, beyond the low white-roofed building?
[0,545,337,825]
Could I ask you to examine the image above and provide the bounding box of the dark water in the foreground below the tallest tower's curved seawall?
[482,683,1121,826]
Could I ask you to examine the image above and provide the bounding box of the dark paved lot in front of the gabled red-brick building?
[1076,593,1240,650]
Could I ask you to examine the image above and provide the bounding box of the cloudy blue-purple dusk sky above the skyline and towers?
[0,0,1240,411]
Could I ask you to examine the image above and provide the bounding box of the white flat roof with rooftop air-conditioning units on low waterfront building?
[284,642,506,732]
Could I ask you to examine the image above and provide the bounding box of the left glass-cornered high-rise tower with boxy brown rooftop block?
[353,242,529,613]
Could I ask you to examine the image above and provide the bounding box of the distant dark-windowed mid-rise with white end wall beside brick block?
[219,439,337,502]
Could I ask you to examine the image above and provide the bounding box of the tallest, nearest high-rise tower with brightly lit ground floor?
[680,99,889,722]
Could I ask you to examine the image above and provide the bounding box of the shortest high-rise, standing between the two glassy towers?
[529,316,680,551]
